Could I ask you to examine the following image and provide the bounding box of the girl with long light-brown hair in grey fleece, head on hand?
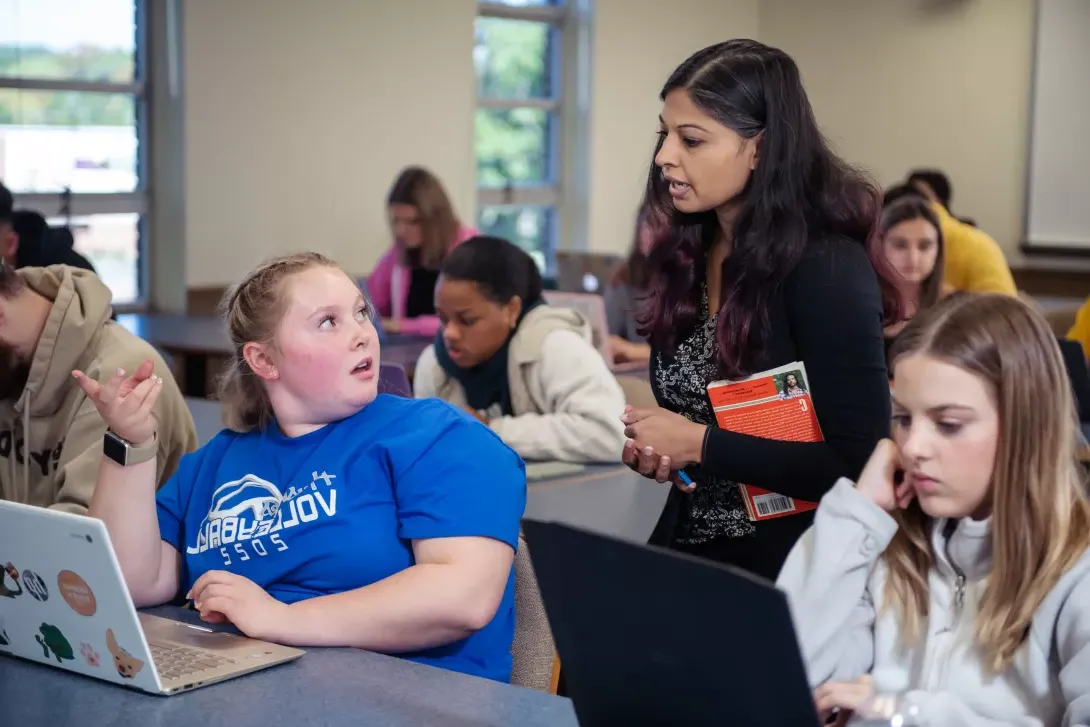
[778,294,1090,727]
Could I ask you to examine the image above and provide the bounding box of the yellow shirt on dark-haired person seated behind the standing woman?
[933,204,1018,295]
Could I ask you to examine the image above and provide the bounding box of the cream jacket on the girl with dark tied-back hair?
[413,305,625,462]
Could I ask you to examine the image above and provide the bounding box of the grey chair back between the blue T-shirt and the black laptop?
[511,535,559,694]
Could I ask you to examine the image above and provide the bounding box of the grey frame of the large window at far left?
[0,0,152,312]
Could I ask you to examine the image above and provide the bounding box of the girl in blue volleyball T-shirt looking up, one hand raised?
[73,254,525,681]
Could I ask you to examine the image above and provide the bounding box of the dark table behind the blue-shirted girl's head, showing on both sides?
[118,313,434,397]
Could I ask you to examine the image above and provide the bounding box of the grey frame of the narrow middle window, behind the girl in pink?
[473,0,593,275]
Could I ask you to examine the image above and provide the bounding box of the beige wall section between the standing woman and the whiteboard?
[761,0,1033,259]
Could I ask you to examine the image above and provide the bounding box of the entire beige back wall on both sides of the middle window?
[183,0,1032,287]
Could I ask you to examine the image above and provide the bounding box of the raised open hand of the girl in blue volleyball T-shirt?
[72,361,162,445]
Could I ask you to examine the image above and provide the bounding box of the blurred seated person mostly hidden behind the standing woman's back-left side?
[604,204,655,364]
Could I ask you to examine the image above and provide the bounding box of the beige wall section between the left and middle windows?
[183,0,476,287]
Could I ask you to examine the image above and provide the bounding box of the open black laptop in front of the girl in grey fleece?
[522,520,819,727]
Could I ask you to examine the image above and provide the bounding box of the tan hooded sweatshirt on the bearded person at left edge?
[0,265,197,514]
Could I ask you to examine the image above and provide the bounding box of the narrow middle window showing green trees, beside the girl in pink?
[473,0,585,274]
